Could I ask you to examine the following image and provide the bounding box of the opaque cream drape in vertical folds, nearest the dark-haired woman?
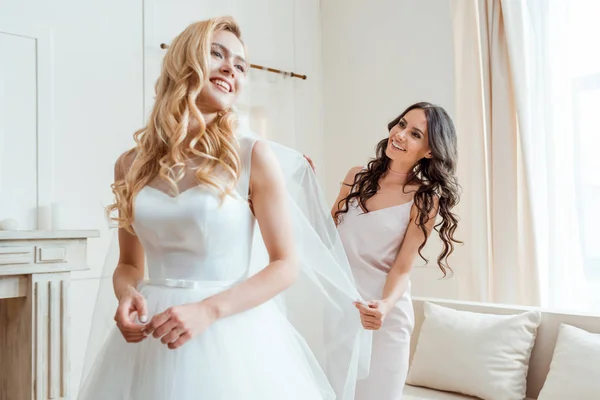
[451,0,540,305]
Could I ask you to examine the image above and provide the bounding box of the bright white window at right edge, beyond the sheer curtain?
[557,1,600,304]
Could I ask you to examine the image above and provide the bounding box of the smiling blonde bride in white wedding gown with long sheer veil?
[79,17,369,400]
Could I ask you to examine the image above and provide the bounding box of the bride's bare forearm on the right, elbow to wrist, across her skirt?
[203,260,298,319]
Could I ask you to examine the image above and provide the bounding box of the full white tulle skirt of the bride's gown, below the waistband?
[78,285,335,400]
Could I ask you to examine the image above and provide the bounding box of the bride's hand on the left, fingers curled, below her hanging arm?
[115,288,148,343]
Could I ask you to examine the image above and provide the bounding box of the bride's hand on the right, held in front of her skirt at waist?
[144,302,216,349]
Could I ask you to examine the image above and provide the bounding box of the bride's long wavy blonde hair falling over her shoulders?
[107,17,243,232]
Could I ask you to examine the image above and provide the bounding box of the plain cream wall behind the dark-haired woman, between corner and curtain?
[322,0,460,298]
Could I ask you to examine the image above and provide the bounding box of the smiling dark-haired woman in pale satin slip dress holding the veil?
[331,103,459,400]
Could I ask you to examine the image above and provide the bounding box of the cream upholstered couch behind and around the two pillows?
[403,298,600,400]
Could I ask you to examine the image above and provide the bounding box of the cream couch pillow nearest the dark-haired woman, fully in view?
[407,302,541,400]
